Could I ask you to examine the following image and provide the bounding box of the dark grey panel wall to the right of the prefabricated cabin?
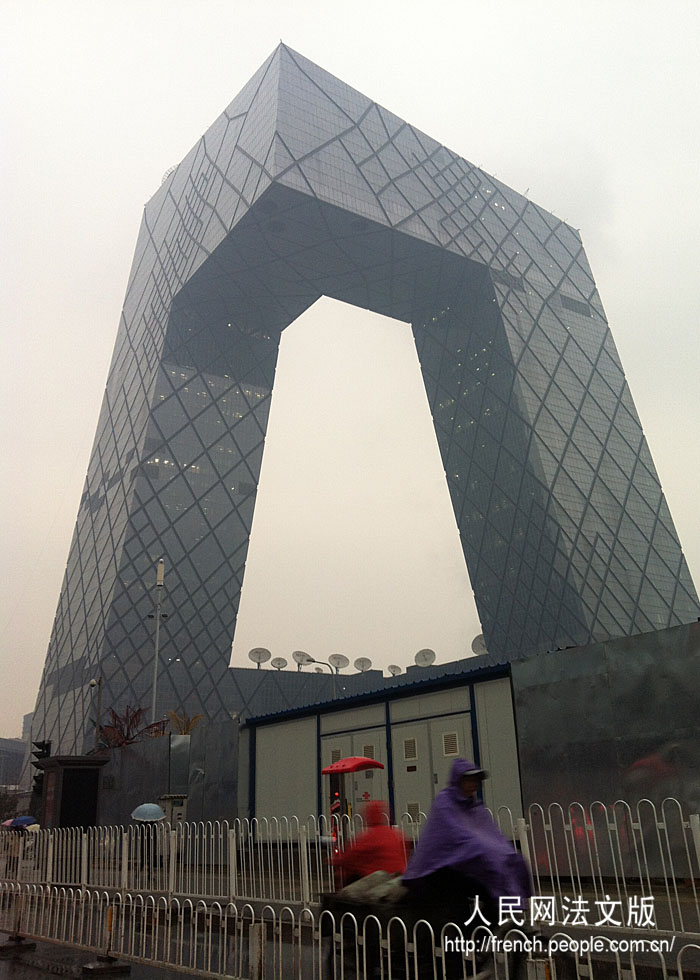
[512,623,700,813]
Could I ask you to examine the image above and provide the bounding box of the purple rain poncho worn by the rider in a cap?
[403,759,532,901]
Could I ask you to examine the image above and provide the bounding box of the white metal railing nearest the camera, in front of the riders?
[0,882,700,980]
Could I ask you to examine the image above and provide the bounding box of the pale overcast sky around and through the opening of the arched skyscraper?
[0,0,700,736]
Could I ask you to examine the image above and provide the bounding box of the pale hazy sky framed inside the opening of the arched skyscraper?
[231,296,480,671]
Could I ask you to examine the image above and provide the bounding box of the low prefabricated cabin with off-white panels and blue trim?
[238,661,522,821]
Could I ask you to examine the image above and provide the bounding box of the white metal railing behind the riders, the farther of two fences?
[0,799,700,934]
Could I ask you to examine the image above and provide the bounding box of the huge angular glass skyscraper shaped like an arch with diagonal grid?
[33,44,700,752]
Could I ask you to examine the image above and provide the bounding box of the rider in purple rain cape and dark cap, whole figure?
[403,759,532,927]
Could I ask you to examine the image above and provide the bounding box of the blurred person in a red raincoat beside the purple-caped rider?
[331,800,409,885]
